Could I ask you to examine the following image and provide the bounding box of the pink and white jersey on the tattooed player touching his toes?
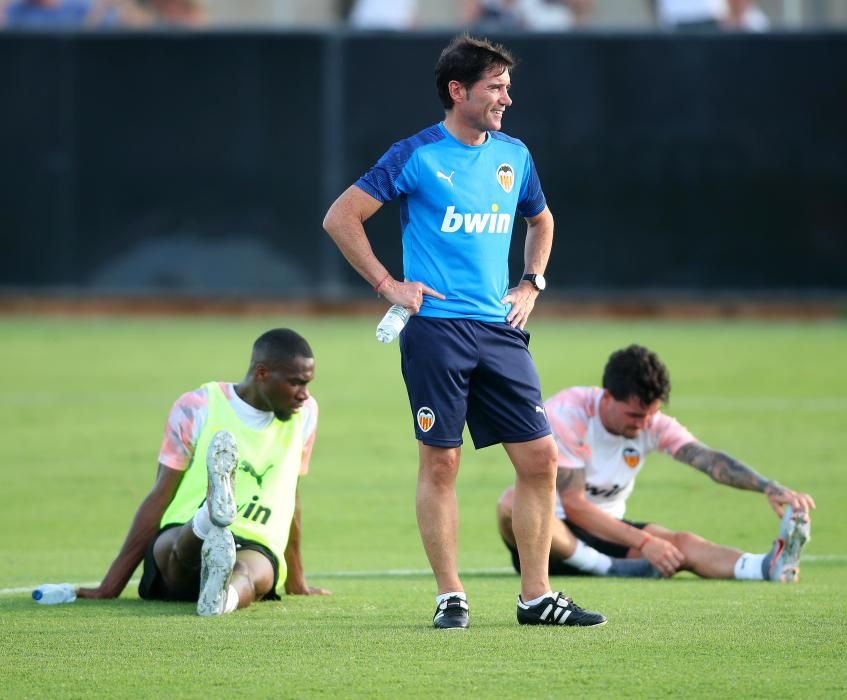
[544,387,696,519]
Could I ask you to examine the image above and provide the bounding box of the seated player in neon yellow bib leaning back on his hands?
[77,329,327,616]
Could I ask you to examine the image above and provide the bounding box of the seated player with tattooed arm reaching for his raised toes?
[497,345,815,583]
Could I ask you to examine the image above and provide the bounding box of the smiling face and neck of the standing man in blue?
[445,67,512,144]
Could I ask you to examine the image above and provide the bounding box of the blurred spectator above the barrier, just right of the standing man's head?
[462,0,593,32]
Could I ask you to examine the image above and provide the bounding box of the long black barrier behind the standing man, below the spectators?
[0,33,847,298]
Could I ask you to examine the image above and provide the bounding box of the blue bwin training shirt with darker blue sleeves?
[356,124,546,322]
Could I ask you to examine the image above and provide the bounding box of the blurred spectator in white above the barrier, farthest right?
[649,0,770,32]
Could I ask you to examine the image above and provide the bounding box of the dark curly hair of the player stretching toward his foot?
[603,345,671,406]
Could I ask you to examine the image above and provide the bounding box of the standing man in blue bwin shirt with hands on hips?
[324,35,606,629]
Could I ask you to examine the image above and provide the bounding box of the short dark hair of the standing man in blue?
[435,34,515,109]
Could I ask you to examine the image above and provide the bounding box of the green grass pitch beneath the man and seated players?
[0,316,847,698]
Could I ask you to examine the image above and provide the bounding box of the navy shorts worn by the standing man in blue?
[400,316,550,449]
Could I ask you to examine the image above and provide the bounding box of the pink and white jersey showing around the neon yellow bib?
[159,382,318,476]
